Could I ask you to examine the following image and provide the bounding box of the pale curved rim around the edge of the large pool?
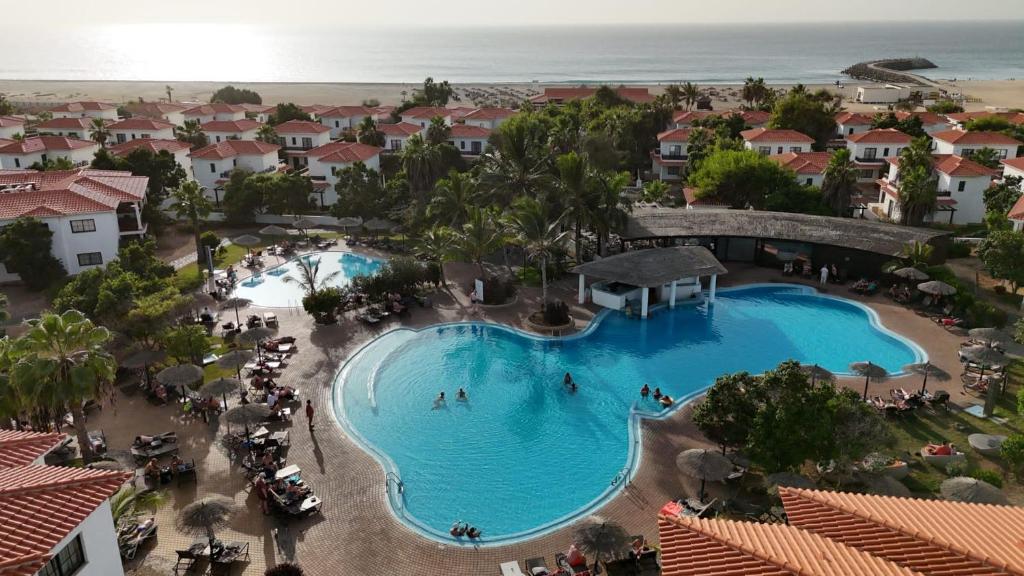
[331,283,928,547]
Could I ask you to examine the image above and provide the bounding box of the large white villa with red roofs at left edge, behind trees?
[0,170,150,282]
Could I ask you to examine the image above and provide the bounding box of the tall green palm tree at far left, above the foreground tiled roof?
[14,310,117,462]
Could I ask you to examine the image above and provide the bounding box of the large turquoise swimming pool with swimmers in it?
[335,285,925,544]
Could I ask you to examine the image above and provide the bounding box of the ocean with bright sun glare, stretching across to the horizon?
[0,20,1024,83]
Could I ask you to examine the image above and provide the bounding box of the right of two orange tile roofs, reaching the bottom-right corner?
[779,488,1024,576]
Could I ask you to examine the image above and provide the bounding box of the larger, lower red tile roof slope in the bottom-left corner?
[0,466,132,576]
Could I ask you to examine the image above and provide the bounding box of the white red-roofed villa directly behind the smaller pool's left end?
[191,140,281,206]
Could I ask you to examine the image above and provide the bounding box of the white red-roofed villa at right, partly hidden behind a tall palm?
[879,155,997,224]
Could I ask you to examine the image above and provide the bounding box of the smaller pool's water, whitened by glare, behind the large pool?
[234,252,384,307]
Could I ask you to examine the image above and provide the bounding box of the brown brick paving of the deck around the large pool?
[108,256,967,576]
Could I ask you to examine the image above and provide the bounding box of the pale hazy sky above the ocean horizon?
[22,0,1024,26]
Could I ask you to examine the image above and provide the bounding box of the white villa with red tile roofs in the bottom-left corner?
[0,430,132,576]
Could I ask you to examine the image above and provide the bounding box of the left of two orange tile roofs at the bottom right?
[658,502,915,576]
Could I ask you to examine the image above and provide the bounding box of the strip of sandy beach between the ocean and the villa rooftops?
[0,80,1024,112]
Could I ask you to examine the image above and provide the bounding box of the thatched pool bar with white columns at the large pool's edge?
[572,246,728,318]
